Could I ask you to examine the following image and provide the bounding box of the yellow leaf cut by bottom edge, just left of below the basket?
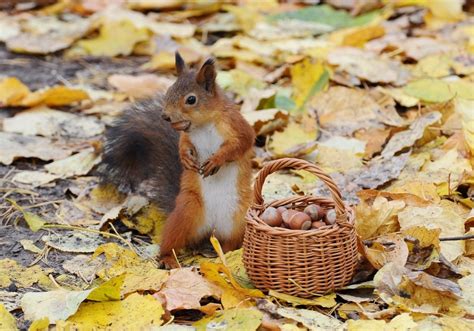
[193,308,263,331]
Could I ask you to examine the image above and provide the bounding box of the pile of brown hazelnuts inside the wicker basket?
[260,204,336,230]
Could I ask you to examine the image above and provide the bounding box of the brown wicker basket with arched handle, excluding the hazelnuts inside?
[243,158,357,297]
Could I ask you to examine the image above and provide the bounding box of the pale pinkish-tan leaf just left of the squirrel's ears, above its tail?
[107,74,173,98]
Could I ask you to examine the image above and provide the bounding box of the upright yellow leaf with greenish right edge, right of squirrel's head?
[290,59,329,110]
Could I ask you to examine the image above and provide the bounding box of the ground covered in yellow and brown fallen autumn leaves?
[0,0,474,330]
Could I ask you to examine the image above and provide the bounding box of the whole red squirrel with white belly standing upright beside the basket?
[102,52,255,267]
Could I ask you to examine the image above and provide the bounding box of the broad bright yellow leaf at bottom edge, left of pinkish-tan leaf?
[64,293,164,330]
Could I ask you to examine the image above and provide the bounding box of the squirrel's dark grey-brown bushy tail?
[99,97,182,213]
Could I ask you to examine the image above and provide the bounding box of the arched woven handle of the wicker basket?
[253,158,348,225]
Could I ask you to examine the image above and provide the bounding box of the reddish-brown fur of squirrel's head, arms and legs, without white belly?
[101,54,255,266]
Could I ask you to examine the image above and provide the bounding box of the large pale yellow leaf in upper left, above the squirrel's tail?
[77,20,148,56]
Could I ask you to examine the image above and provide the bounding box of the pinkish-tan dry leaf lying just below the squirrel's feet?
[155,268,222,311]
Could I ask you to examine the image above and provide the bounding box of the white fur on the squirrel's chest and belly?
[189,124,239,238]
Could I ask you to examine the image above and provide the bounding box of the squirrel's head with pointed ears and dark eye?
[163,52,222,131]
